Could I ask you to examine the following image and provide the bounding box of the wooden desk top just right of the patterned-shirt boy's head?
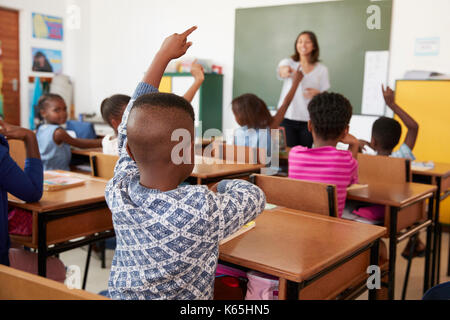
[191,156,265,179]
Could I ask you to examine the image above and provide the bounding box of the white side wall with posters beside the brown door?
[0,0,91,127]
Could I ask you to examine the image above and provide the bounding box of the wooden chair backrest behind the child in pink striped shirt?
[250,174,338,217]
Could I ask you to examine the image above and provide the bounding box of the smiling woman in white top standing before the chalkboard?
[277,31,330,148]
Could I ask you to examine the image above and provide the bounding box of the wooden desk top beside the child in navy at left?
[8,170,108,212]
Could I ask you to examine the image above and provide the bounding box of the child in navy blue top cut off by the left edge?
[0,120,66,282]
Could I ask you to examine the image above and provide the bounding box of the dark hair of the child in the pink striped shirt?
[308,92,352,140]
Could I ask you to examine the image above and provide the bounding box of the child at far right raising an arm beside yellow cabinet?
[353,86,425,258]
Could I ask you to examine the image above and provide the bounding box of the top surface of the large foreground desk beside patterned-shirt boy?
[220,207,386,282]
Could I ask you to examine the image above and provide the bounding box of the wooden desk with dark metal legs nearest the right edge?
[347,182,436,300]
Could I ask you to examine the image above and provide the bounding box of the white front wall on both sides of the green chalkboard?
[90,0,450,129]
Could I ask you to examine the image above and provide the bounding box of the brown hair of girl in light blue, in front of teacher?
[231,93,272,129]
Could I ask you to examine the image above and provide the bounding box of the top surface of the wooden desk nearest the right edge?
[347,182,437,207]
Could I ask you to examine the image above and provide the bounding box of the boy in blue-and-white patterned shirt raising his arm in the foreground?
[105,27,265,300]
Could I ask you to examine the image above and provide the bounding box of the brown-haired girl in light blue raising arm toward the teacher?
[231,69,303,150]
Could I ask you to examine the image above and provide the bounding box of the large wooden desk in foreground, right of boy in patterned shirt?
[219,207,386,299]
